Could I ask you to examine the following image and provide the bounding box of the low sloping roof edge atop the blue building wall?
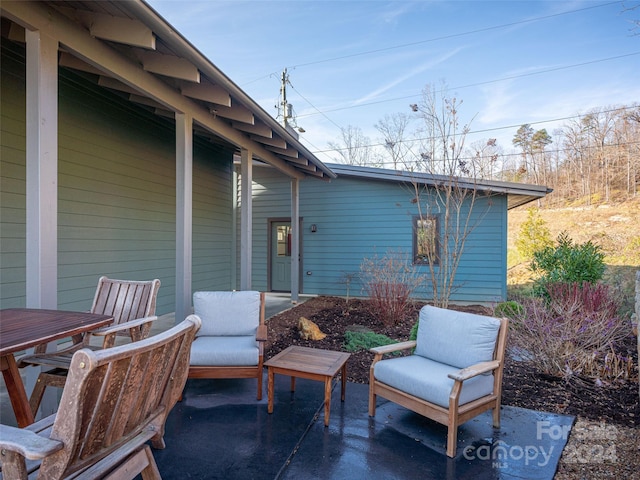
[327,163,553,210]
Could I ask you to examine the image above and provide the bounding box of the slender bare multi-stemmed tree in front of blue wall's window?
[411,86,490,308]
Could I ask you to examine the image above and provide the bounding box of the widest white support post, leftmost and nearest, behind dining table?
[25,29,58,309]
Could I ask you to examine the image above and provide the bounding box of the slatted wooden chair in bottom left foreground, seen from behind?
[0,315,201,480]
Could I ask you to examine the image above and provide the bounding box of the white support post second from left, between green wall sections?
[175,113,193,323]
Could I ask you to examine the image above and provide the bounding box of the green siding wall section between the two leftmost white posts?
[58,71,176,313]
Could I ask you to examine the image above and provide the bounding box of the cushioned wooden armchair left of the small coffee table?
[189,291,267,400]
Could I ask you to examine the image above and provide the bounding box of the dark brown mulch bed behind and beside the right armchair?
[265,296,640,427]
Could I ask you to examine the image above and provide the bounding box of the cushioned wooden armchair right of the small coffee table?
[369,306,508,457]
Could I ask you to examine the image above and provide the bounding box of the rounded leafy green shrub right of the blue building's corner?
[530,232,605,297]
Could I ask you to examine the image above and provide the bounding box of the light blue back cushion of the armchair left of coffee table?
[193,291,260,337]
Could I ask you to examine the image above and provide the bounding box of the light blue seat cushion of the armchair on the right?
[373,355,493,408]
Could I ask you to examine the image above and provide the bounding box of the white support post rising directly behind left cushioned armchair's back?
[240,148,253,290]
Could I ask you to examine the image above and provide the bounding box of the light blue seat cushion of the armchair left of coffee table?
[189,336,259,367]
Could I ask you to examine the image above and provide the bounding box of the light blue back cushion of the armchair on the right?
[415,305,500,368]
